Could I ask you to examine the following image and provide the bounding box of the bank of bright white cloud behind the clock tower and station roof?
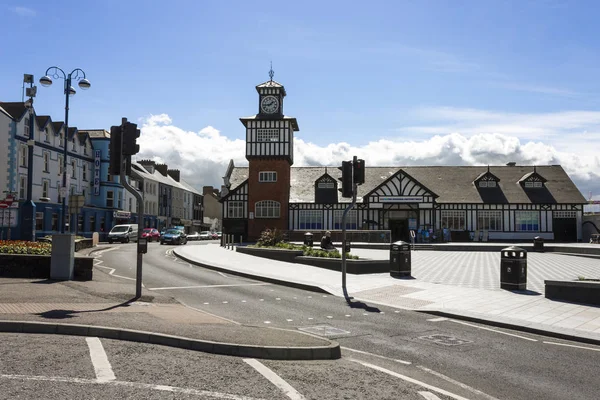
[138,110,600,197]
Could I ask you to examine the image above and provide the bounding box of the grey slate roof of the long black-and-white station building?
[229,165,587,204]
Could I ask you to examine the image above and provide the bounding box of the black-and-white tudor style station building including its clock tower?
[221,75,587,242]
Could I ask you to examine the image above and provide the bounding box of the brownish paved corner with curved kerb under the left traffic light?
[0,246,341,360]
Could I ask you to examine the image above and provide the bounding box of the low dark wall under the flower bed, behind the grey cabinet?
[0,254,94,281]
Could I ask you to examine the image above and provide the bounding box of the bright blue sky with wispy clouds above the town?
[0,0,600,203]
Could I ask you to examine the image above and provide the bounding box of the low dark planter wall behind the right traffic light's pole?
[236,247,390,274]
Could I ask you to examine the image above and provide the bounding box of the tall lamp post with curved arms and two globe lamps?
[40,67,91,233]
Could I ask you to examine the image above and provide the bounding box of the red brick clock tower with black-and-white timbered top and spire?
[240,68,299,240]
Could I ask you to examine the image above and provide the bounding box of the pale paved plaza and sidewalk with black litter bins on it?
[174,243,600,344]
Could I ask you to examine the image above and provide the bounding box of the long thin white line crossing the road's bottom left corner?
[0,374,261,400]
